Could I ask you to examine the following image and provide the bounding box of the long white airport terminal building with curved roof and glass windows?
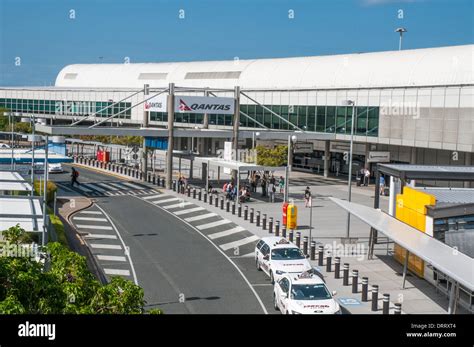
[0,45,474,185]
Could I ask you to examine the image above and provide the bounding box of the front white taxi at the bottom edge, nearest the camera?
[273,272,341,314]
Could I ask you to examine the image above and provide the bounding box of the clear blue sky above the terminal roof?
[0,0,474,86]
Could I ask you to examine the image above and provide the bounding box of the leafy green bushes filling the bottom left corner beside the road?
[0,227,150,314]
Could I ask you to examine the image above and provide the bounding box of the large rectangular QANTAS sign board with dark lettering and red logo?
[174,95,234,114]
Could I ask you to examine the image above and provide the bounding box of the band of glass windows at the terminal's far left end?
[0,98,132,119]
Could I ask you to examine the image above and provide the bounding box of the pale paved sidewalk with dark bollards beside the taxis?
[158,179,466,314]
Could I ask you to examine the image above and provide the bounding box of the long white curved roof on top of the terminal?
[56,45,474,89]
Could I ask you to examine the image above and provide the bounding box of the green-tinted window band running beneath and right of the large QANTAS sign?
[150,104,379,136]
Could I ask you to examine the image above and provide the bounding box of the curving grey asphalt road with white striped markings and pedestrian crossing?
[50,166,273,314]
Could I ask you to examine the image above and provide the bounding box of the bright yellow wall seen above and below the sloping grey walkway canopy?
[394,187,436,277]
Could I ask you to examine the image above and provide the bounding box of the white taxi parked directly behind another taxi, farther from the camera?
[255,236,312,284]
